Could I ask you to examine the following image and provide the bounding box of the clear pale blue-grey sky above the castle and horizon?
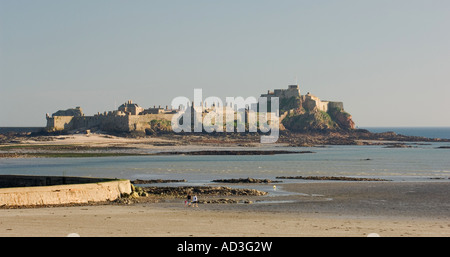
[0,0,450,127]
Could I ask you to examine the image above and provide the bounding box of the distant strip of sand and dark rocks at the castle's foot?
[0,129,450,158]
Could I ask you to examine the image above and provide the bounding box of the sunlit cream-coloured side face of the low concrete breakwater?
[0,176,131,206]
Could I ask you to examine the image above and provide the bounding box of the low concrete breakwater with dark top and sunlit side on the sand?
[0,175,131,207]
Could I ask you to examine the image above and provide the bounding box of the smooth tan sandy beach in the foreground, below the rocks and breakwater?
[0,181,450,237]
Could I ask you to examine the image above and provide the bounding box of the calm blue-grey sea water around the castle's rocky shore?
[0,127,450,185]
